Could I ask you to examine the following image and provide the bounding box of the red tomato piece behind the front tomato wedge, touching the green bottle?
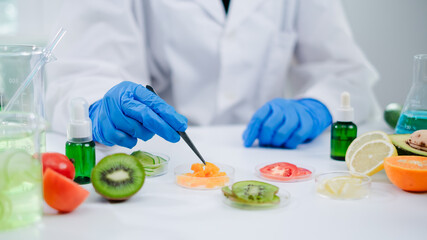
[42,152,76,180]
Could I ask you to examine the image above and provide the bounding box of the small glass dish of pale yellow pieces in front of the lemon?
[315,171,371,200]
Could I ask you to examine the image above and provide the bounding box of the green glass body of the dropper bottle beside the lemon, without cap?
[331,122,357,161]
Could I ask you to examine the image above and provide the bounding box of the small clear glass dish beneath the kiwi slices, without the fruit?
[223,190,291,210]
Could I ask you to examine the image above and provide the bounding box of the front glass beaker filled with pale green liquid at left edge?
[0,112,44,230]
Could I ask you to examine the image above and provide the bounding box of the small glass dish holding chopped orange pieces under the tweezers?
[175,164,234,190]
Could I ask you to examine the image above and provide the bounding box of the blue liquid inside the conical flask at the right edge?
[395,111,427,134]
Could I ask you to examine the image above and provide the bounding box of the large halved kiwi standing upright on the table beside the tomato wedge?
[91,153,145,201]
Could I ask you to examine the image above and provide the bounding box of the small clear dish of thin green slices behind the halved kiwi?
[131,151,170,177]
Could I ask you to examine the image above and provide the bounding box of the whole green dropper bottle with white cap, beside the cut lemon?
[331,92,357,161]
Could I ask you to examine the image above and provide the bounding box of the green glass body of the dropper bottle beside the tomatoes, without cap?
[65,141,95,184]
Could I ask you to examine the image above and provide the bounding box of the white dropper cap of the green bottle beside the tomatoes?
[67,98,92,143]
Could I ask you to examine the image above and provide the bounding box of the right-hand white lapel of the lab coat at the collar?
[226,0,268,31]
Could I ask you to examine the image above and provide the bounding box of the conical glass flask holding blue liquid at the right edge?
[395,54,427,134]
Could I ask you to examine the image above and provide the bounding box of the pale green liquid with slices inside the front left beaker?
[0,148,43,230]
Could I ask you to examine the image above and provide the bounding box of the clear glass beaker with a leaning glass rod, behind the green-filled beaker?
[0,45,45,117]
